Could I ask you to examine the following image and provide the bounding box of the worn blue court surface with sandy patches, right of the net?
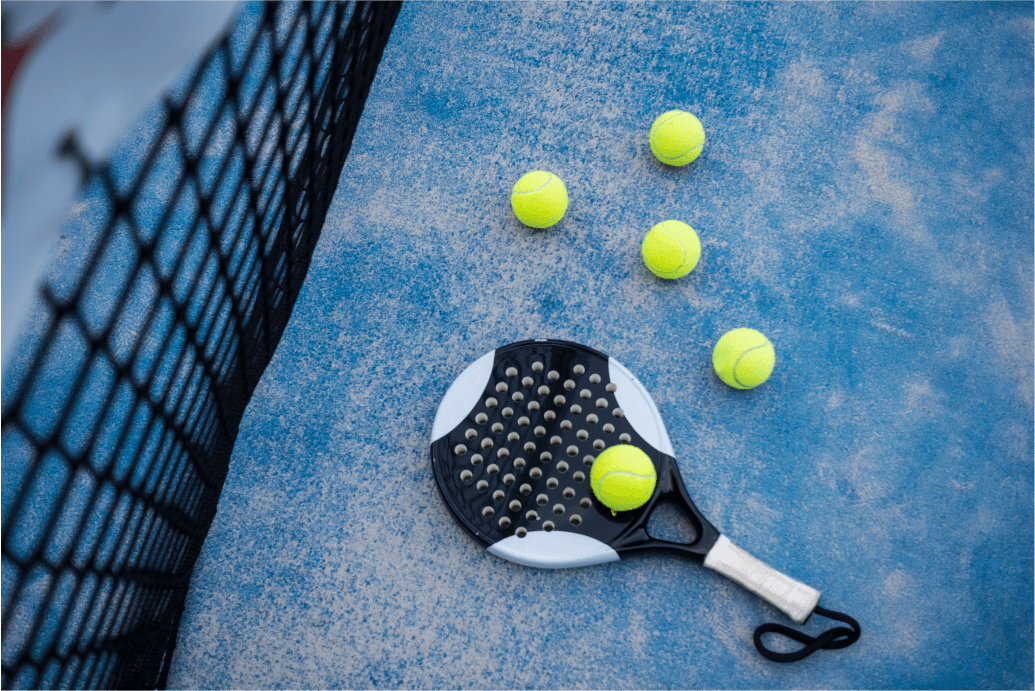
[170,1,1035,689]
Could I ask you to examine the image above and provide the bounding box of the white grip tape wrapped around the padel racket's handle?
[705,535,821,624]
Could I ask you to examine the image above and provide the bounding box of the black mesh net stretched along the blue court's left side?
[0,2,400,689]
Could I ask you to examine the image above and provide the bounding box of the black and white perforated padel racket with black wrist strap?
[431,339,860,662]
